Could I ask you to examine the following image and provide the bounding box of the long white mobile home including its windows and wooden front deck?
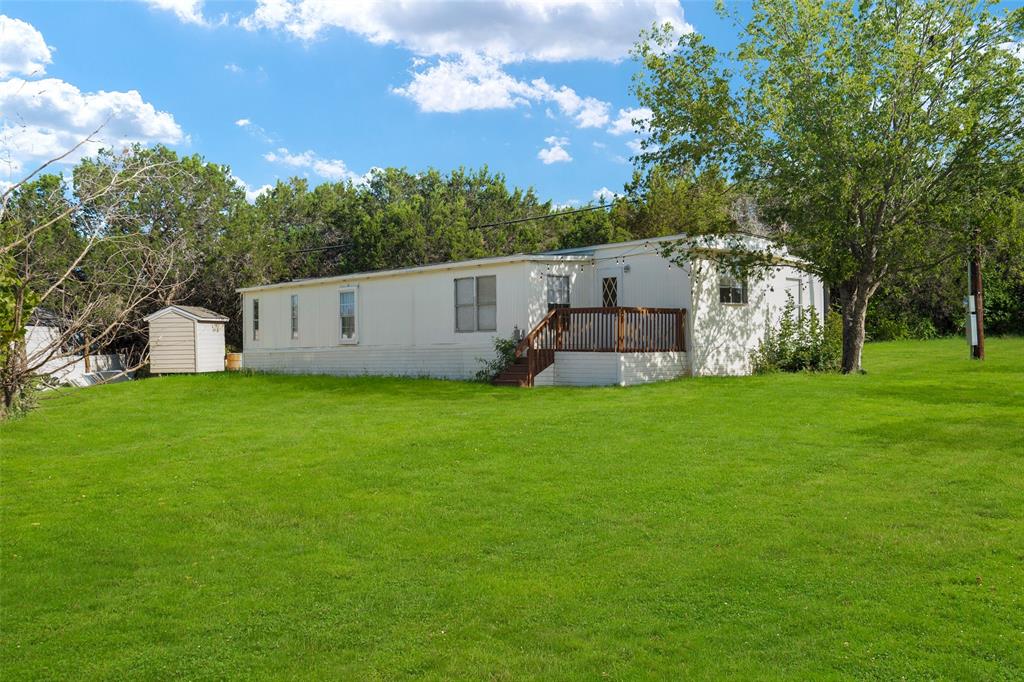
[239,237,824,385]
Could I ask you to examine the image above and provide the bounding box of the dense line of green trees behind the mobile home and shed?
[0,124,1024,409]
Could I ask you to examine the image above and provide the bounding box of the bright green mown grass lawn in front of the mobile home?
[0,339,1024,680]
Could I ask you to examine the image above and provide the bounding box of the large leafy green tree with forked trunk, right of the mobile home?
[635,0,1024,372]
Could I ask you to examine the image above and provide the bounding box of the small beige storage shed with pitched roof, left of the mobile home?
[145,305,227,374]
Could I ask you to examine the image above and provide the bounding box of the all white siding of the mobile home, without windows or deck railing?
[242,236,822,378]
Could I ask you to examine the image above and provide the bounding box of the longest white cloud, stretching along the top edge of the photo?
[241,0,692,62]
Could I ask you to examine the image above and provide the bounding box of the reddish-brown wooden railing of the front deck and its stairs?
[516,307,686,386]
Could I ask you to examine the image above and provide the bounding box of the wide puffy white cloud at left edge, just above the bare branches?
[0,78,187,175]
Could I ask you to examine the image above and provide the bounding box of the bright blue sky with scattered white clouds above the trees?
[0,0,749,204]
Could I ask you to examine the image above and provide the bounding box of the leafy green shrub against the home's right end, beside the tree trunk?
[751,296,843,374]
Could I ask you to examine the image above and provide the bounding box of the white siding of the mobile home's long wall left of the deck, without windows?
[236,262,529,378]
